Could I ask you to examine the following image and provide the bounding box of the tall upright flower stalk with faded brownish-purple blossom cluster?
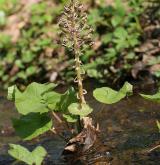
[59,0,93,109]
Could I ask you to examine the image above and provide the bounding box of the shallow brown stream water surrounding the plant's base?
[0,85,160,165]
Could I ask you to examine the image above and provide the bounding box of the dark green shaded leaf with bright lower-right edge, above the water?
[13,113,52,140]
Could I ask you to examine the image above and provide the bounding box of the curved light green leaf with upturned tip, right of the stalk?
[93,82,133,104]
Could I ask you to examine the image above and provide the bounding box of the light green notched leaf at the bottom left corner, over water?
[8,144,47,165]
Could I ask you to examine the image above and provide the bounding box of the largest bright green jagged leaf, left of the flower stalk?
[12,82,56,115]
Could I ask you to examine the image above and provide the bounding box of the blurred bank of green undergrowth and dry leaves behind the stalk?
[0,0,160,88]
